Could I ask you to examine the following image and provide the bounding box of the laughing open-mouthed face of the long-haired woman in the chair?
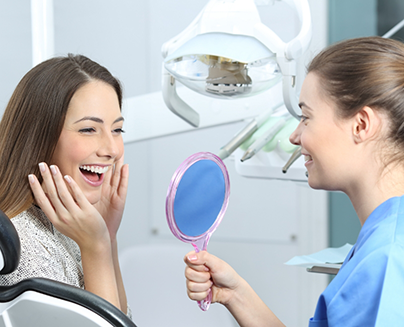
[51,81,124,204]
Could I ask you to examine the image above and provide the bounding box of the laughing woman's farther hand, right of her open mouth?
[94,156,129,241]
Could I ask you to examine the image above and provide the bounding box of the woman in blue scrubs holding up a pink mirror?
[184,37,404,327]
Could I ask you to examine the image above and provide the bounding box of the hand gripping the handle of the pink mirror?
[184,251,243,305]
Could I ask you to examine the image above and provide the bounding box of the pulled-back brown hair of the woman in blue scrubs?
[308,37,404,153]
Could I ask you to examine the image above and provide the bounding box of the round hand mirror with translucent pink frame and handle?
[166,152,230,311]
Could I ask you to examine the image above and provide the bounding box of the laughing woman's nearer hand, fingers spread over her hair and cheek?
[28,163,110,251]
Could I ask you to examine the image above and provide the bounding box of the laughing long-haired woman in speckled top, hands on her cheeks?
[0,55,130,316]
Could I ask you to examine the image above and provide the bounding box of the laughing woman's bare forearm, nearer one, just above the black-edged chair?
[80,244,120,311]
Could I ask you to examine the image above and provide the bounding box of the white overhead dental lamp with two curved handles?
[162,0,312,127]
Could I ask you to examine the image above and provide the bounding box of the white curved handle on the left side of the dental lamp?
[163,66,199,127]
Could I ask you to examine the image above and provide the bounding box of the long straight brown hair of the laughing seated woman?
[0,54,122,218]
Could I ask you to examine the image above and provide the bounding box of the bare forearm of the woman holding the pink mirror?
[225,280,285,327]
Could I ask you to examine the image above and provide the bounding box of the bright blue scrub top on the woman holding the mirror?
[309,196,404,327]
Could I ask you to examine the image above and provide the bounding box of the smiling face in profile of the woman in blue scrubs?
[290,73,353,191]
